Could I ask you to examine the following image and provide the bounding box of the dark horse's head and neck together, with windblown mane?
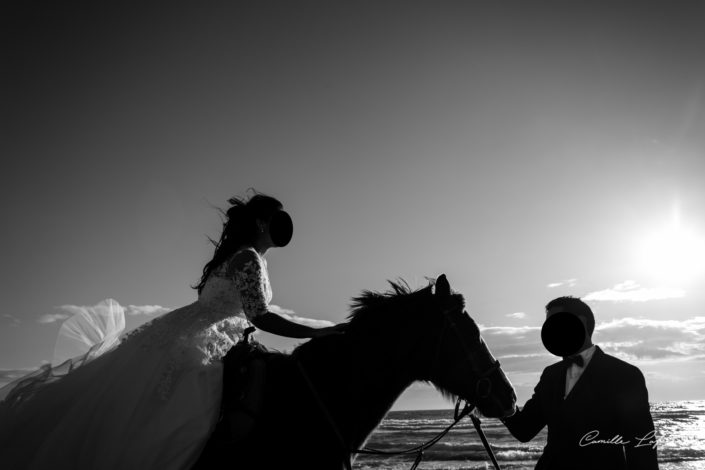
[344,275,516,417]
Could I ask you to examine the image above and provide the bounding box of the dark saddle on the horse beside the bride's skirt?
[216,327,268,444]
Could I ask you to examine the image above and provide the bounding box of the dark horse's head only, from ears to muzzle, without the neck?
[419,275,516,417]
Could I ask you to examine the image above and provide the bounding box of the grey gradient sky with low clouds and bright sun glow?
[0,1,705,409]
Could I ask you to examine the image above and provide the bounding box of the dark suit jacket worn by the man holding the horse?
[503,347,658,470]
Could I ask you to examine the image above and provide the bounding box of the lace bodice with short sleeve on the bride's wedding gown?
[114,248,272,399]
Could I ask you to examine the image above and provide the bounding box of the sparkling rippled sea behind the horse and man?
[354,400,705,470]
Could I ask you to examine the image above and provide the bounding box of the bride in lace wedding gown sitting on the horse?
[0,194,339,470]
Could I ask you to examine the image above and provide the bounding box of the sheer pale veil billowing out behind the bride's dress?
[0,299,125,408]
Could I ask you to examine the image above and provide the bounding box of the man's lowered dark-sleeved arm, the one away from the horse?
[618,369,658,470]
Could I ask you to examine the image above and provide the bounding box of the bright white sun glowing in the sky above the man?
[639,223,705,284]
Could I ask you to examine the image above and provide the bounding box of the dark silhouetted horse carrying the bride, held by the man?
[194,275,516,470]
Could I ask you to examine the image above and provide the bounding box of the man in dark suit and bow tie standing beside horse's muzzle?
[502,297,658,470]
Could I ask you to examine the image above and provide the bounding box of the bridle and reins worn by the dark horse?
[295,309,500,470]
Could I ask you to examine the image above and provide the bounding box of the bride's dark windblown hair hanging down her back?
[194,191,283,294]
